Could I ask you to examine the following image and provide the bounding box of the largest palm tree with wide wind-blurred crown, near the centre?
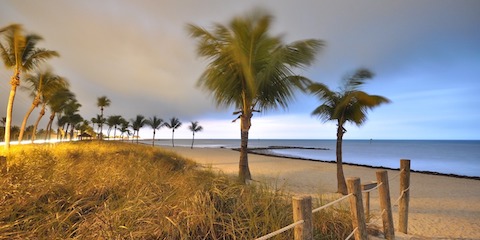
[188,11,323,182]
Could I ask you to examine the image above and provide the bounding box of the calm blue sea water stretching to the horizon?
[145,139,480,177]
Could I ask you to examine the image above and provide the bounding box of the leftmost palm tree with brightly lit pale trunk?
[0,24,58,151]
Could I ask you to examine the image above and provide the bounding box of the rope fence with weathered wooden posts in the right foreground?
[256,159,410,240]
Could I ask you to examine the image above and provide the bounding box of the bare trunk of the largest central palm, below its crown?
[238,114,252,183]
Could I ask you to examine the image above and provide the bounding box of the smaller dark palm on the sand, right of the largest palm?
[309,69,390,194]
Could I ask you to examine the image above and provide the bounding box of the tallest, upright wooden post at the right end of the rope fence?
[398,159,410,234]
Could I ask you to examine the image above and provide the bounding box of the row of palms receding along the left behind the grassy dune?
[0,24,202,148]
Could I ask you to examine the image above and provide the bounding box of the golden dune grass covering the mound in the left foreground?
[0,141,351,239]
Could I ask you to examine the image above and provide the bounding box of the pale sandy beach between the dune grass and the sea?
[162,146,480,239]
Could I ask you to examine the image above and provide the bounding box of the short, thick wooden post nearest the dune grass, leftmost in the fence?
[292,196,313,240]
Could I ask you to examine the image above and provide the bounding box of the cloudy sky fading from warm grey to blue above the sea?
[0,0,480,140]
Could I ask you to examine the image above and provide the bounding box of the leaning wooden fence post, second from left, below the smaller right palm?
[347,177,368,240]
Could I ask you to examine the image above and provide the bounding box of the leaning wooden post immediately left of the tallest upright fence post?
[377,170,395,240]
